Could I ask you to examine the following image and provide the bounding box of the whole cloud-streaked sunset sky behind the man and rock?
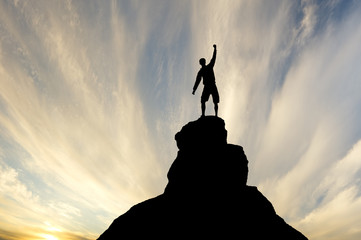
[0,0,361,240]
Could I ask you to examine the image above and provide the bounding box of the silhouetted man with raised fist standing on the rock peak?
[192,44,219,117]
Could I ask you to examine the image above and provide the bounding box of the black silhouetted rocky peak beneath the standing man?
[99,116,307,240]
